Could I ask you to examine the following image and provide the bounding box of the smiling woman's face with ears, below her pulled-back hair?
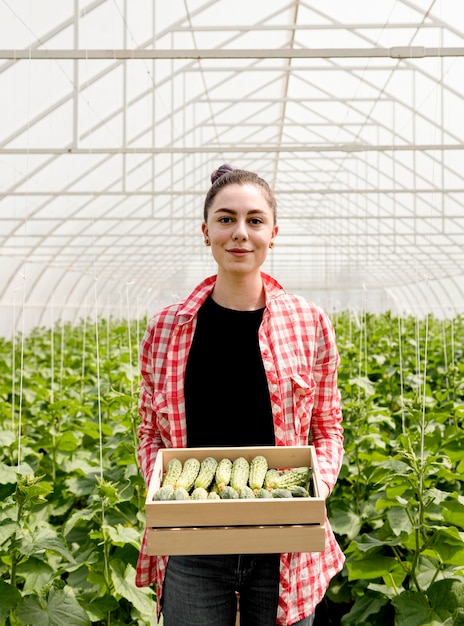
[202,184,278,274]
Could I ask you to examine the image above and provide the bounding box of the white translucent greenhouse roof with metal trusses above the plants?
[0,0,464,334]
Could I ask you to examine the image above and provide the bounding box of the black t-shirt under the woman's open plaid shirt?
[185,297,275,448]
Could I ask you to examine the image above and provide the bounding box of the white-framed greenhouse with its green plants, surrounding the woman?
[0,0,464,626]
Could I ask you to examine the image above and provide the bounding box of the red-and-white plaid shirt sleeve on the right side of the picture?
[311,311,343,491]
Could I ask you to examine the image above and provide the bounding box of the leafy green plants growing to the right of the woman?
[329,316,464,626]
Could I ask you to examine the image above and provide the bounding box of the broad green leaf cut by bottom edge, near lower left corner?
[16,587,90,626]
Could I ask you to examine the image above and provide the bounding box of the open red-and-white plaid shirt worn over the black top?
[136,274,344,626]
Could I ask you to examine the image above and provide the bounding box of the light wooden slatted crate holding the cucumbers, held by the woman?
[145,446,325,555]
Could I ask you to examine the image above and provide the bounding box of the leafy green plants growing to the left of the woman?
[0,321,155,626]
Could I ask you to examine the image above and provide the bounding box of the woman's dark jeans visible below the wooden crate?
[162,554,314,626]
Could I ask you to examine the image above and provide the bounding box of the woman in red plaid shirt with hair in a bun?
[136,165,344,626]
